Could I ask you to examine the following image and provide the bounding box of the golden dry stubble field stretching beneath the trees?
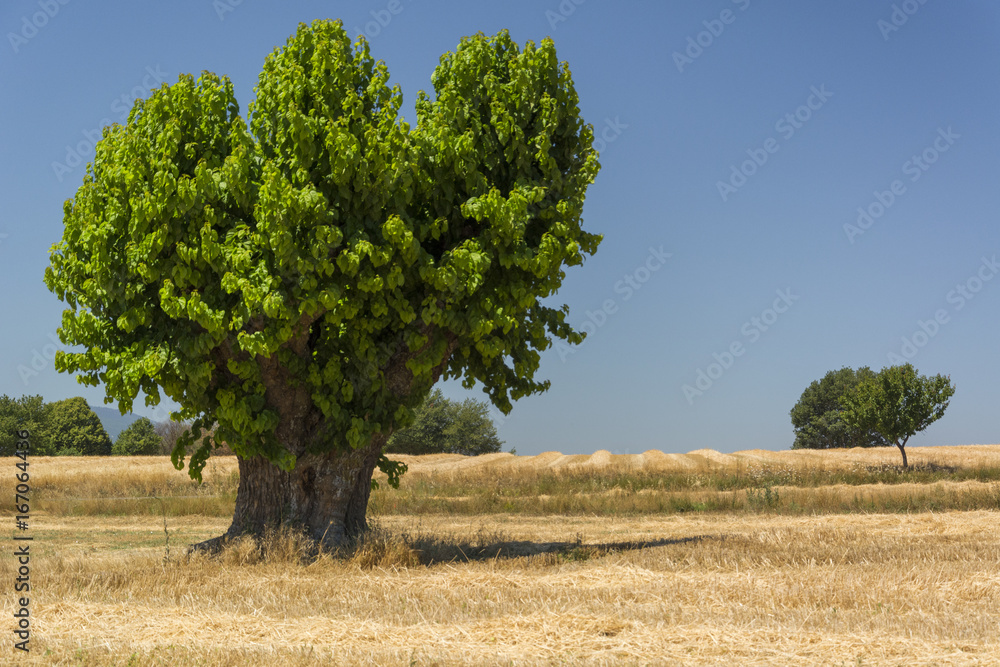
[0,446,1000,667]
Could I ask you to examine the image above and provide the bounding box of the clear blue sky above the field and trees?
[0,0,1000,454]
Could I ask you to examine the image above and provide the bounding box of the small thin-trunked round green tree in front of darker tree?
[841,364,955,468]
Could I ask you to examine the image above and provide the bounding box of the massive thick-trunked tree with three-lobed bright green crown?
[45,21,600,547]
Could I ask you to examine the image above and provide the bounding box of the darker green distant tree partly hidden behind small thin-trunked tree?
[791,366,890,449]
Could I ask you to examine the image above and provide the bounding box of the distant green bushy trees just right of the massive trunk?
[385,389,503,456]
